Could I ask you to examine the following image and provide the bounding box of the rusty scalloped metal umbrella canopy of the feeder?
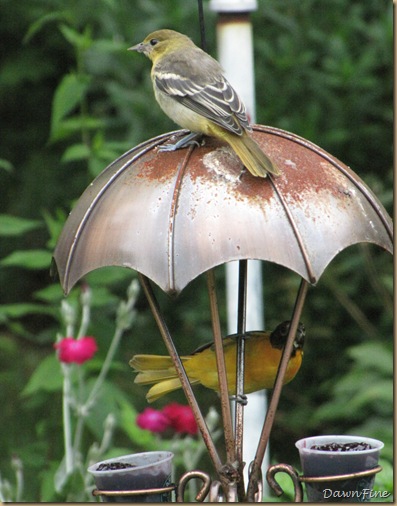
[54,125,392,293]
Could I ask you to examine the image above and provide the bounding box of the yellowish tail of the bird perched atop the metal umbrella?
[227,133,280,177]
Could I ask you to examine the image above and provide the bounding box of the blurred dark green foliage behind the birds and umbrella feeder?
[0,0,393,501]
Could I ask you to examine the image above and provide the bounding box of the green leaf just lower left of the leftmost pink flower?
[22,352,63,396]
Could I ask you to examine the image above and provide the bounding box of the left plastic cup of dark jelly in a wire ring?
[88,452,174,502]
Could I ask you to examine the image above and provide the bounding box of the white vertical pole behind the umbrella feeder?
[210,0,269,494]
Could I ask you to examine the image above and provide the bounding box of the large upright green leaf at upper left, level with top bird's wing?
[50,74,91,140]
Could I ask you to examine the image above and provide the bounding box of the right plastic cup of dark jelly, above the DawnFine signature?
[295,436,384,502]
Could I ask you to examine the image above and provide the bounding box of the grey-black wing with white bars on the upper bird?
[154,52,250,135]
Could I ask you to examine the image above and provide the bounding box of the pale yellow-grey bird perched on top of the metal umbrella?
[129,30,280,177]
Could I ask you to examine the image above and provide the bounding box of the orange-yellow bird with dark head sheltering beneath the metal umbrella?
[130,321,305,402]
